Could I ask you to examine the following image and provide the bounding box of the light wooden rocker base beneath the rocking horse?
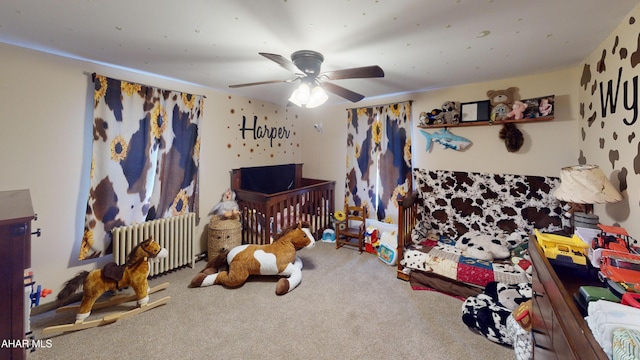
[42,282,171,335]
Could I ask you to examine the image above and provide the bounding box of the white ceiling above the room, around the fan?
[0,0,639,104]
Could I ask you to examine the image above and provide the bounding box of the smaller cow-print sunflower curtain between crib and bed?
[344,101,411,224]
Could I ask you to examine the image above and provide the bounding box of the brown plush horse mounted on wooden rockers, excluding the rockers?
[58,239,169,323]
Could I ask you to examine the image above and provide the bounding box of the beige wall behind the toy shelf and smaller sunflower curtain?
[303,69,578,208]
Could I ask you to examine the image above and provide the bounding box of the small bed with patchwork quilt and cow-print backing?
[398,168,562,298]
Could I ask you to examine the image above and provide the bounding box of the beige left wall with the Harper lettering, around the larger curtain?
[0,44,302,296]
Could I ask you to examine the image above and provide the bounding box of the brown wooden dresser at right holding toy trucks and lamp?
[529,236,608,360]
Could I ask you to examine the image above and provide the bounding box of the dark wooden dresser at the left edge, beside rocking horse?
[0,190,35,360]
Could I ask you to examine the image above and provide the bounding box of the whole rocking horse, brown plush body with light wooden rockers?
[43,239,170,334]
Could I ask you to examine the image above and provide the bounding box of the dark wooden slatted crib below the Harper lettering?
[231,164,335,244]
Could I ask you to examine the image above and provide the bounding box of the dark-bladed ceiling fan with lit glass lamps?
[229,50,384,107]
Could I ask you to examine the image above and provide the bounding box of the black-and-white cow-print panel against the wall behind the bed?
[413,168,563,238]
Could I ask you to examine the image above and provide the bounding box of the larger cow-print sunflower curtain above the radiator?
[79,75,204,260]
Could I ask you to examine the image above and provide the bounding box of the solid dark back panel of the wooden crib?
[231,164,302,194]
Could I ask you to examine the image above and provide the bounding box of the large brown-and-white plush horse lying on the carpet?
[189,222,315,295]
